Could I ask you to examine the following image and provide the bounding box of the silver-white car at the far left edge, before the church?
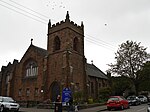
[0,96,20,112]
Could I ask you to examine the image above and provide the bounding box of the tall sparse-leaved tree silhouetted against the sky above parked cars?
[109,40,149,94]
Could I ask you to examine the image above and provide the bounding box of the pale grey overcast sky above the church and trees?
[0,0,150,72]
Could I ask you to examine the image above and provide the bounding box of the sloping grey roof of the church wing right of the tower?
[86,63,108,79]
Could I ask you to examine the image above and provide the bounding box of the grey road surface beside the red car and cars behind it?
[102,104,148,112]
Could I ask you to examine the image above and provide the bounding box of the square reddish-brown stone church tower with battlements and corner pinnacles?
[46,12,86,100]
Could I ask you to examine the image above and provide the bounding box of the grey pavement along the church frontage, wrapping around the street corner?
[20,105,106,112]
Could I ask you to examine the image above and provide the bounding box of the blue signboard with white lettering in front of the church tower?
[62,88,72,103]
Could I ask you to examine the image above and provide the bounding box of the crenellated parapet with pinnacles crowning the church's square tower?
[48,11,84,34]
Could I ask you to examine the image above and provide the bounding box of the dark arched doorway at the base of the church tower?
[50,81,60,102]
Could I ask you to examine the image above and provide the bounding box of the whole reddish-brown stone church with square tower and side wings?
[0,12,108,102]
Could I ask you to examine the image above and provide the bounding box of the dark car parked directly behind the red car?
[127,96,141,105]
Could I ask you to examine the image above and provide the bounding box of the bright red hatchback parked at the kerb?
[107,96,129,110]
